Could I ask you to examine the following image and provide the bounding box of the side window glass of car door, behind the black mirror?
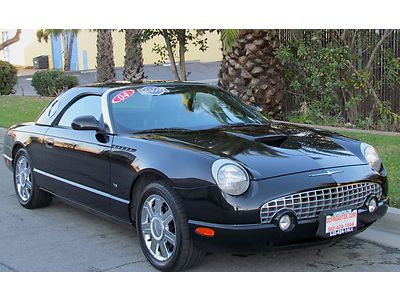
[58,95,101,127]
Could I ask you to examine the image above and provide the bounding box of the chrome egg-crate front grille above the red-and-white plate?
[260,182,382,223]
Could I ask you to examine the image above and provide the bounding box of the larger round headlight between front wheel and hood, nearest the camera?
[211,159,250,196]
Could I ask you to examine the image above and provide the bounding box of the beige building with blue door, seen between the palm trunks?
[0,29,222,70]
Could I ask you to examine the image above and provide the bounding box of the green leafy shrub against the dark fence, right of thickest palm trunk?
[276,40,356,118]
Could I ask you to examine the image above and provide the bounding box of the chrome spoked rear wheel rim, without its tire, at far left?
[15,156,32,203]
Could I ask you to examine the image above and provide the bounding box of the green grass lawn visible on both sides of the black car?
[0,96,400,208]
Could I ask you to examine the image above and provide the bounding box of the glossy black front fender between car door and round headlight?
[110,136,216,203]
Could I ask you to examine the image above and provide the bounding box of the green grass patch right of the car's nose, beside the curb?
[338,131,400,208]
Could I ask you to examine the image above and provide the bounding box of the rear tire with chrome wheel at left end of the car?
[13,148,52,209]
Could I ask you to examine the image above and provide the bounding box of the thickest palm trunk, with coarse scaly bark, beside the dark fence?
[218,29,286,119]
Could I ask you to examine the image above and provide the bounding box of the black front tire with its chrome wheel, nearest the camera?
[136,181,204,271]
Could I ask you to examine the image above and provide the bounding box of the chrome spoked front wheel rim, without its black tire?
[141,195,176,261]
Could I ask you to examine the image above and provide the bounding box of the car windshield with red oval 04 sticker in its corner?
[109,85,268,133]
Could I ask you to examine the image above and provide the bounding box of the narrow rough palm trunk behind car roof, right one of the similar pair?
[124,29,144,81]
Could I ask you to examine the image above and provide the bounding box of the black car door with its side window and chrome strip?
[39,95,112,213]
